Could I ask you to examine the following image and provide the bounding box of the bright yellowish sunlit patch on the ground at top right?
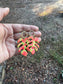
[38,0,63,16]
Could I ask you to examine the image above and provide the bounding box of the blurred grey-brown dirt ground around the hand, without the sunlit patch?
[0,0,63,84]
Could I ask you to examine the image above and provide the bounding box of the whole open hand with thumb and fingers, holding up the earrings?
[0,7,41,63]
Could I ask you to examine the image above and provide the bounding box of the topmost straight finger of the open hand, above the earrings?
[12,24,39,33]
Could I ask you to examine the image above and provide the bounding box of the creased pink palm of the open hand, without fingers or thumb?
[0,24,16,60]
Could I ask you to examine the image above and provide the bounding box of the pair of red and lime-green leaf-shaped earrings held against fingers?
[17,31,39,56]
